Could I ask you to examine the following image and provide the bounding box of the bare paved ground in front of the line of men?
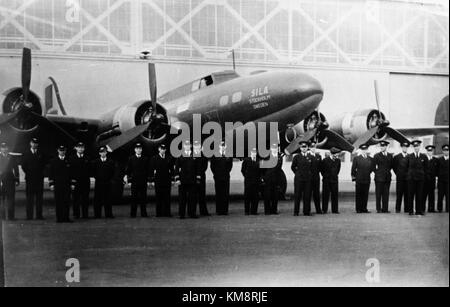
[3,197,449,286]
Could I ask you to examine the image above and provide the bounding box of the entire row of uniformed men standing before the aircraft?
[0,139,448,222]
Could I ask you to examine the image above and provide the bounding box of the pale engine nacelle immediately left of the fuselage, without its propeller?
[99,100,168,145]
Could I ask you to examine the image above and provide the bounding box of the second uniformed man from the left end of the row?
[22,138,47,220]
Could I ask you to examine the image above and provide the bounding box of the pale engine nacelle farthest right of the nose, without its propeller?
[329,109,387,145]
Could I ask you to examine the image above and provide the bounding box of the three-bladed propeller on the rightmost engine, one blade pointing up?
[353,80,409,150]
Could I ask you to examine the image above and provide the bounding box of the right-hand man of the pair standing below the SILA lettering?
[261,144,283,215]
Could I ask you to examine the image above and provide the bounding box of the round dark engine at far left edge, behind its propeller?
[2,87,43,133]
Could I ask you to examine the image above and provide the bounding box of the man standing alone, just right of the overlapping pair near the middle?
[211,142,233,215]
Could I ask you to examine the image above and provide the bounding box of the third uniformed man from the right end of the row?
[408,140,428,215]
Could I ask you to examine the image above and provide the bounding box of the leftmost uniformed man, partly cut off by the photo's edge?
[0,143,19,221]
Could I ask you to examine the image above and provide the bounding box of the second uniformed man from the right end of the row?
[423,145,437,213]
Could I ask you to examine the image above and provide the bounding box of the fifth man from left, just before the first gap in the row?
[91,146,115,219]
